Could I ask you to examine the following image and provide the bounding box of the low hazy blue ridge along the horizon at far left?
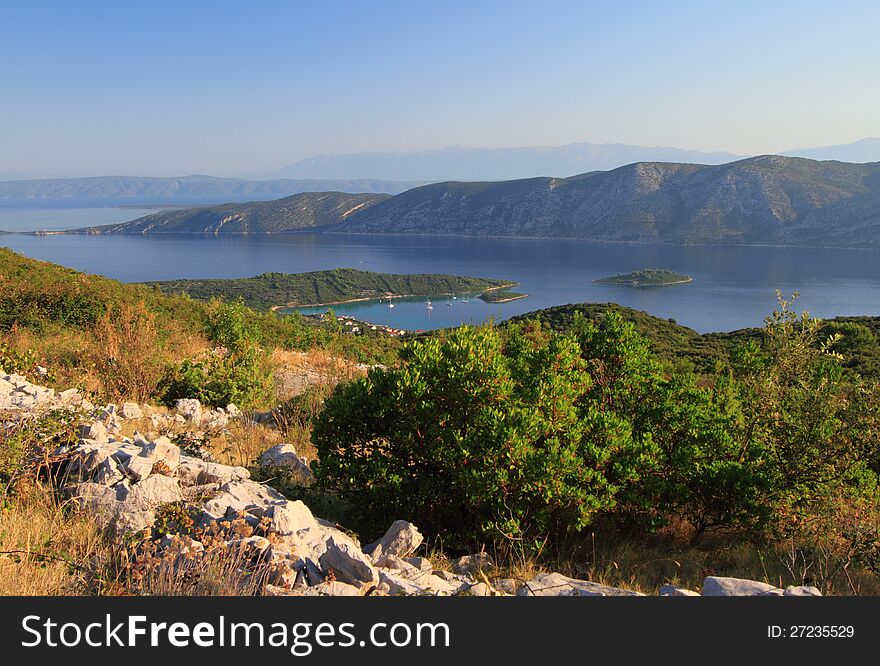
[0,176,423,205]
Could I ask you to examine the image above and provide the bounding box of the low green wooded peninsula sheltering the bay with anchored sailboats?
[149,268,514,310]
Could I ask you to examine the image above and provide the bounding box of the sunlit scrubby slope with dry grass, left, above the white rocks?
[0,248,400,407]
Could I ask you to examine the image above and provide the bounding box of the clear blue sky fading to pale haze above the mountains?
[0,0,880,178]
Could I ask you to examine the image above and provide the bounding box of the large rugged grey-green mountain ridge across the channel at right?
[329,155,880,247]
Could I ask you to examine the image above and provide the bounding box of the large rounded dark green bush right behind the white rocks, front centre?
[313,326,631,544]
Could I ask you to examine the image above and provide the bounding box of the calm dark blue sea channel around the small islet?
[0,209,880,332]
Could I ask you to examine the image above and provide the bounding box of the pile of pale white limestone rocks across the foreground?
[0,374,832,597]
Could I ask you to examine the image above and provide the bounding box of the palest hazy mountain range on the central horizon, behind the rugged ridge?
[272,143,741,181]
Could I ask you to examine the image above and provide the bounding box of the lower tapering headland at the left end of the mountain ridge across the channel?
[77,192,389,234]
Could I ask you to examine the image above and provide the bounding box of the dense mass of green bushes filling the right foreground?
[313,296,880,588]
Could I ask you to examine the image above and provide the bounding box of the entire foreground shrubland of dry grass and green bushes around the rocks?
[0,250,880,594]
